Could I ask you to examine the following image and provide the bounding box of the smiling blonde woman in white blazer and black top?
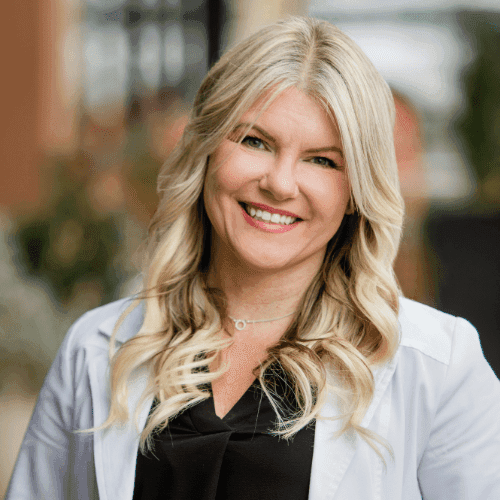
[7,18,500,500]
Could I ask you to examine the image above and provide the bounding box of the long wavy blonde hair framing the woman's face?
[104,18,403,456]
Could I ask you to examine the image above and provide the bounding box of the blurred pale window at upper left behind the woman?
[84,0,213,115]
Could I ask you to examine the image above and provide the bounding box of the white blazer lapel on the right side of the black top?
[309,356,397,500]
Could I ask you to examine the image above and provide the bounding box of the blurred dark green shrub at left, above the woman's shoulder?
[16,159,121,304]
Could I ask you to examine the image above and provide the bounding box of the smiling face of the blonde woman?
[204,84,350,272]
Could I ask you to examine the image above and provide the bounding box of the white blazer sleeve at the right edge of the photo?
[418,318,500,500]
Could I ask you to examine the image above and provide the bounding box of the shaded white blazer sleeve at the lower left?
[5,320,97,500]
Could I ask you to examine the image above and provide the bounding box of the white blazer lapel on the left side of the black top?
[89,300,153,500]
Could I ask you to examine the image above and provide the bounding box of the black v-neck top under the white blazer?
[133,379,314,500]
